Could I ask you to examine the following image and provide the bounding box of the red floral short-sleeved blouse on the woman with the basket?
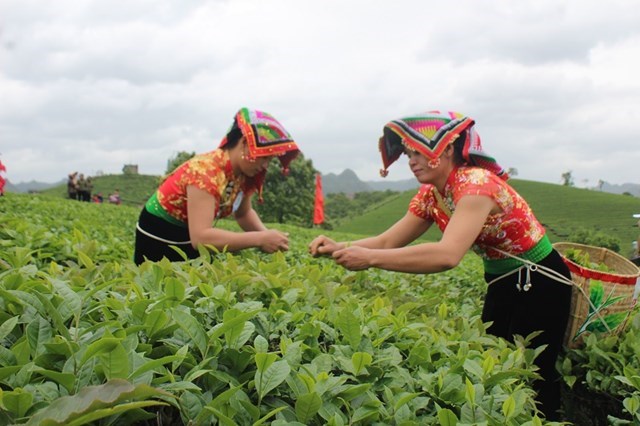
[409,167,545,259]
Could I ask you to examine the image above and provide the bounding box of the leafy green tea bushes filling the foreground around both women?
[0,194,640,425]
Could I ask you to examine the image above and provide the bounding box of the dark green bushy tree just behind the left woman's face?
[253,154,318,227]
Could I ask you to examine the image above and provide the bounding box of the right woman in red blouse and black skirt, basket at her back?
[309,111,571,419]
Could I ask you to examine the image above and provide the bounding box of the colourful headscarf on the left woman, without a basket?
[218,108,300,202]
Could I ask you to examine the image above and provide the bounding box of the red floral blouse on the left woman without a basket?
[156,149,255,223]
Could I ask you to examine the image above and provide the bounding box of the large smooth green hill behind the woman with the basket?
[336,179,640,254]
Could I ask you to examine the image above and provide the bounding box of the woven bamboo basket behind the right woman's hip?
[553,242,640,348]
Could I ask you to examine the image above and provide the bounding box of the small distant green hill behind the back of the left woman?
[40,174,160,206]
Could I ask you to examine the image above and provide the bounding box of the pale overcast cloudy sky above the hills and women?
[0,0,640,186]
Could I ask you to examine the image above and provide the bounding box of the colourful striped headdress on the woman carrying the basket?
[379,111,508,180]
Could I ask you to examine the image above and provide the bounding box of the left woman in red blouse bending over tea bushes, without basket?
[134,108,299,264]
